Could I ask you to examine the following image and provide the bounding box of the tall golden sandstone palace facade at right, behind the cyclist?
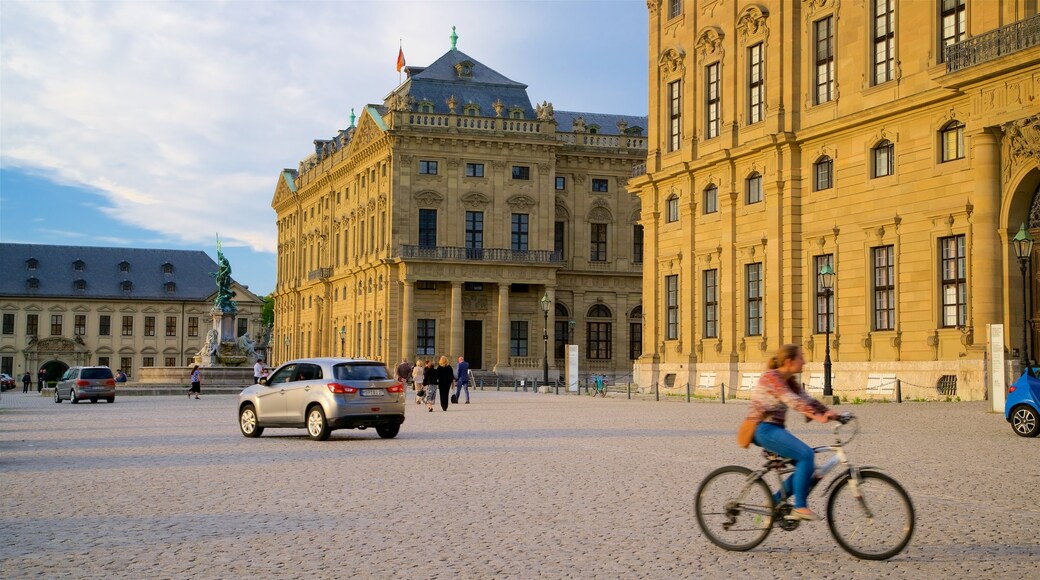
[629,0,1040,399]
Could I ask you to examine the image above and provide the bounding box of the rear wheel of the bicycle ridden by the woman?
[696,466,773,552]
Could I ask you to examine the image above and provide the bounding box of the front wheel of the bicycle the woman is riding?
[827,471,914,560]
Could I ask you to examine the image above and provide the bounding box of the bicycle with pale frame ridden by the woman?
[696,413,914,560]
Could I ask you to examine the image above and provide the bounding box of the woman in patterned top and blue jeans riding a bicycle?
[748,344,838,522]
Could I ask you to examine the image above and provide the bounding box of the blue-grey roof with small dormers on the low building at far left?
[0,243,227,301]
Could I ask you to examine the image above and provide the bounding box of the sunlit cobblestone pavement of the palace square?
[0,392,1040,579]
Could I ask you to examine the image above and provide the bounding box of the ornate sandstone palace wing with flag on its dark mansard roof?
[271,31,646,379]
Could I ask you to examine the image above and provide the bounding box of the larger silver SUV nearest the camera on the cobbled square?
[238,358,405,441]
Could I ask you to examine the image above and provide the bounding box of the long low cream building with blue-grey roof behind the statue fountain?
[0,243,263,384]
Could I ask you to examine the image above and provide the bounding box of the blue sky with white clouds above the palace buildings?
[0,0,648,294]
